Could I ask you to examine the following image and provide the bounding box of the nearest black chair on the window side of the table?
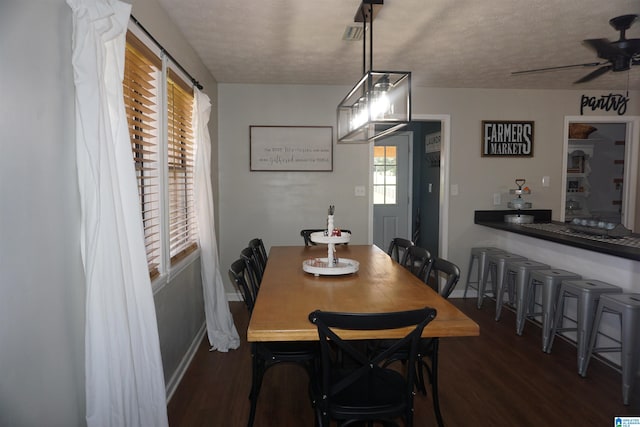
[229,258,319,427]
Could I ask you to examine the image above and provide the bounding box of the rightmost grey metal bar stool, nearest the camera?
[580,293,640,405]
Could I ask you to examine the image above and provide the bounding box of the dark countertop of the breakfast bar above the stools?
[474,209,640,261]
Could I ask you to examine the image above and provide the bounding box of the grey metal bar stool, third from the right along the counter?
[516,268,582,351]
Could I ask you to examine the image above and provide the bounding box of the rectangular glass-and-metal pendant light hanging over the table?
[337,0,411,142]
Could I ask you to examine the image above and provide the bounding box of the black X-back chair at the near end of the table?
[309,307,436,427]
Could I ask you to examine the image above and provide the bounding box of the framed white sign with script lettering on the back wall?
[249,126,333,172]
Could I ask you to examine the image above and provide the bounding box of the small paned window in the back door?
[373,145,398,205]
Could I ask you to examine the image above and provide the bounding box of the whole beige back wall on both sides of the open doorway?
[219,84,640,292]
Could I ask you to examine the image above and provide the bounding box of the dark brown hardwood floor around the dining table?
[168,299,640,427]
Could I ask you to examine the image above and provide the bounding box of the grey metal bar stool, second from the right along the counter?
[547,280,622,373]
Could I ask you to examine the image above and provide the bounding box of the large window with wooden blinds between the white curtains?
[123,32,197,279]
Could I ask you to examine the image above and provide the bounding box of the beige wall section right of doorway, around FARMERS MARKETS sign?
[413,88,640,284]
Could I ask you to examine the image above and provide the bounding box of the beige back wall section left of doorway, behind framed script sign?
[218,84,370,292]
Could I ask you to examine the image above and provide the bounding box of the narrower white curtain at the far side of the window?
[193,89,240,352]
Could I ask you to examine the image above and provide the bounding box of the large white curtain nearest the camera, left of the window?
[68,0,168,427]
